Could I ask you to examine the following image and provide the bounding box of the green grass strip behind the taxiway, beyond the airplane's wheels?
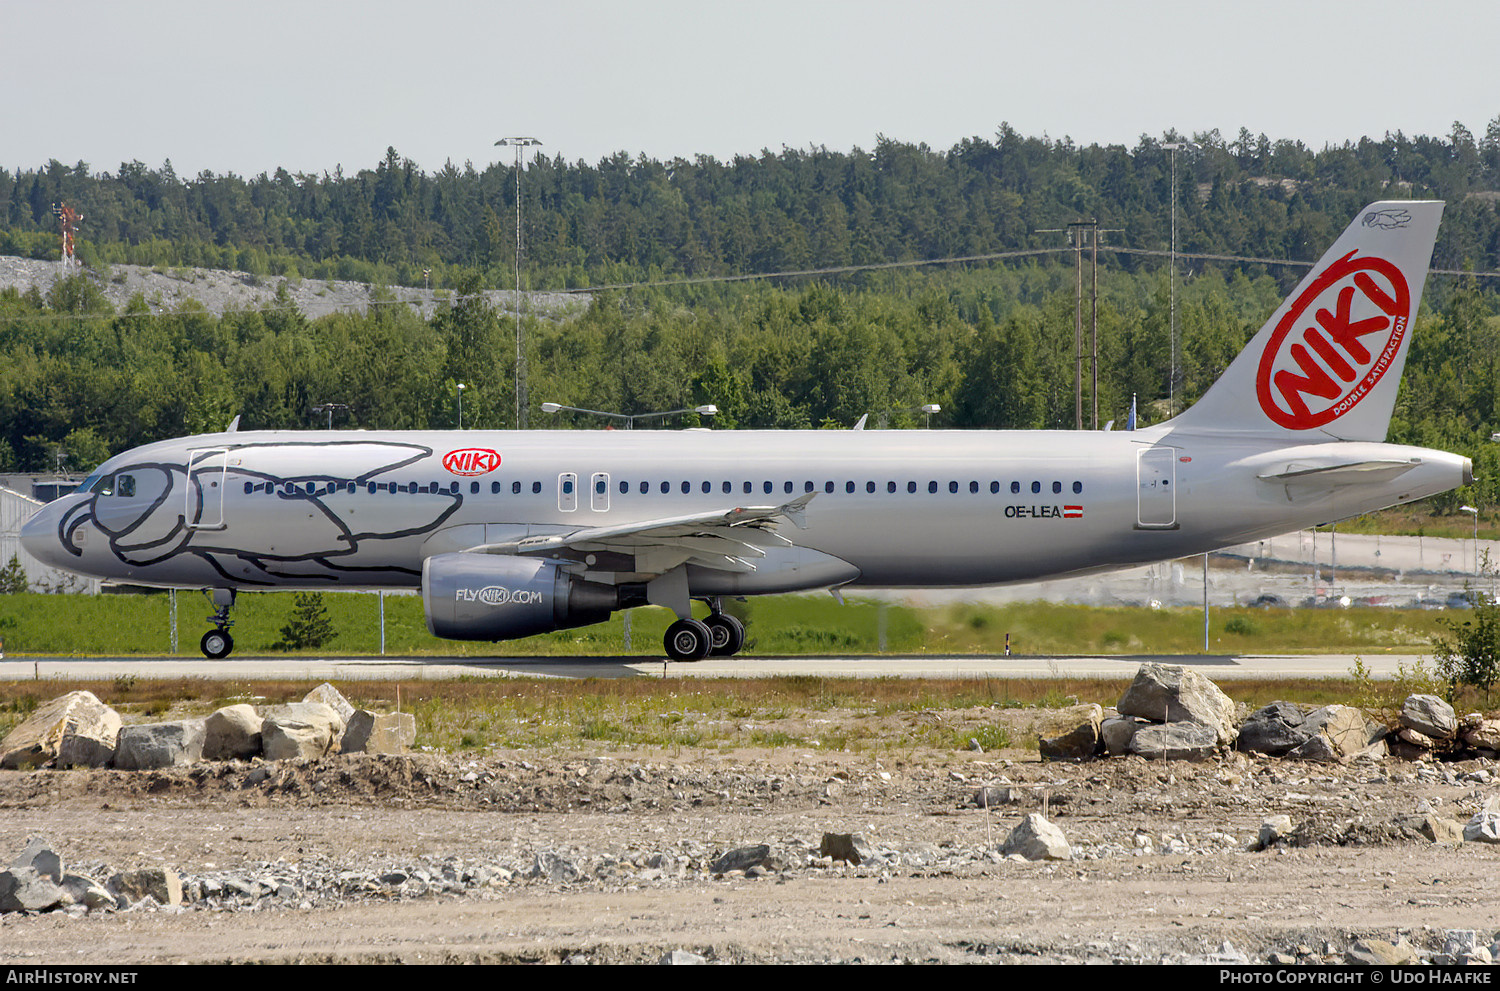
[0,592,1443,657]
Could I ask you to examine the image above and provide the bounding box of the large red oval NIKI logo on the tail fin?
[1256,252,1412,430]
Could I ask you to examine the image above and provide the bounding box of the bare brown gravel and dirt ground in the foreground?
[0,717,1500,964]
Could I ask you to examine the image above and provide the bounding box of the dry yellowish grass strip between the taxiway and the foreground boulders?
[0,670,1482,753]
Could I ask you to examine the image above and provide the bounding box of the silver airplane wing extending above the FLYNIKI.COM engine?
[468,492,818,574]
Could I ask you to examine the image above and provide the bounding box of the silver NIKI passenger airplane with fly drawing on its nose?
[21,201,1473,661]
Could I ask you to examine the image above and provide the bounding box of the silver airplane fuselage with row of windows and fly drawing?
[29,427,1469,594]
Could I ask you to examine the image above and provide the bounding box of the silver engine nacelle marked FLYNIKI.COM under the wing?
[422,553,620,640]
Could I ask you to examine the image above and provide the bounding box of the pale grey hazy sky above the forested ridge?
[0,0,1500,177]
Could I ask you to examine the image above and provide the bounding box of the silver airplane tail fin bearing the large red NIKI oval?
[1170,201,1443,441]
